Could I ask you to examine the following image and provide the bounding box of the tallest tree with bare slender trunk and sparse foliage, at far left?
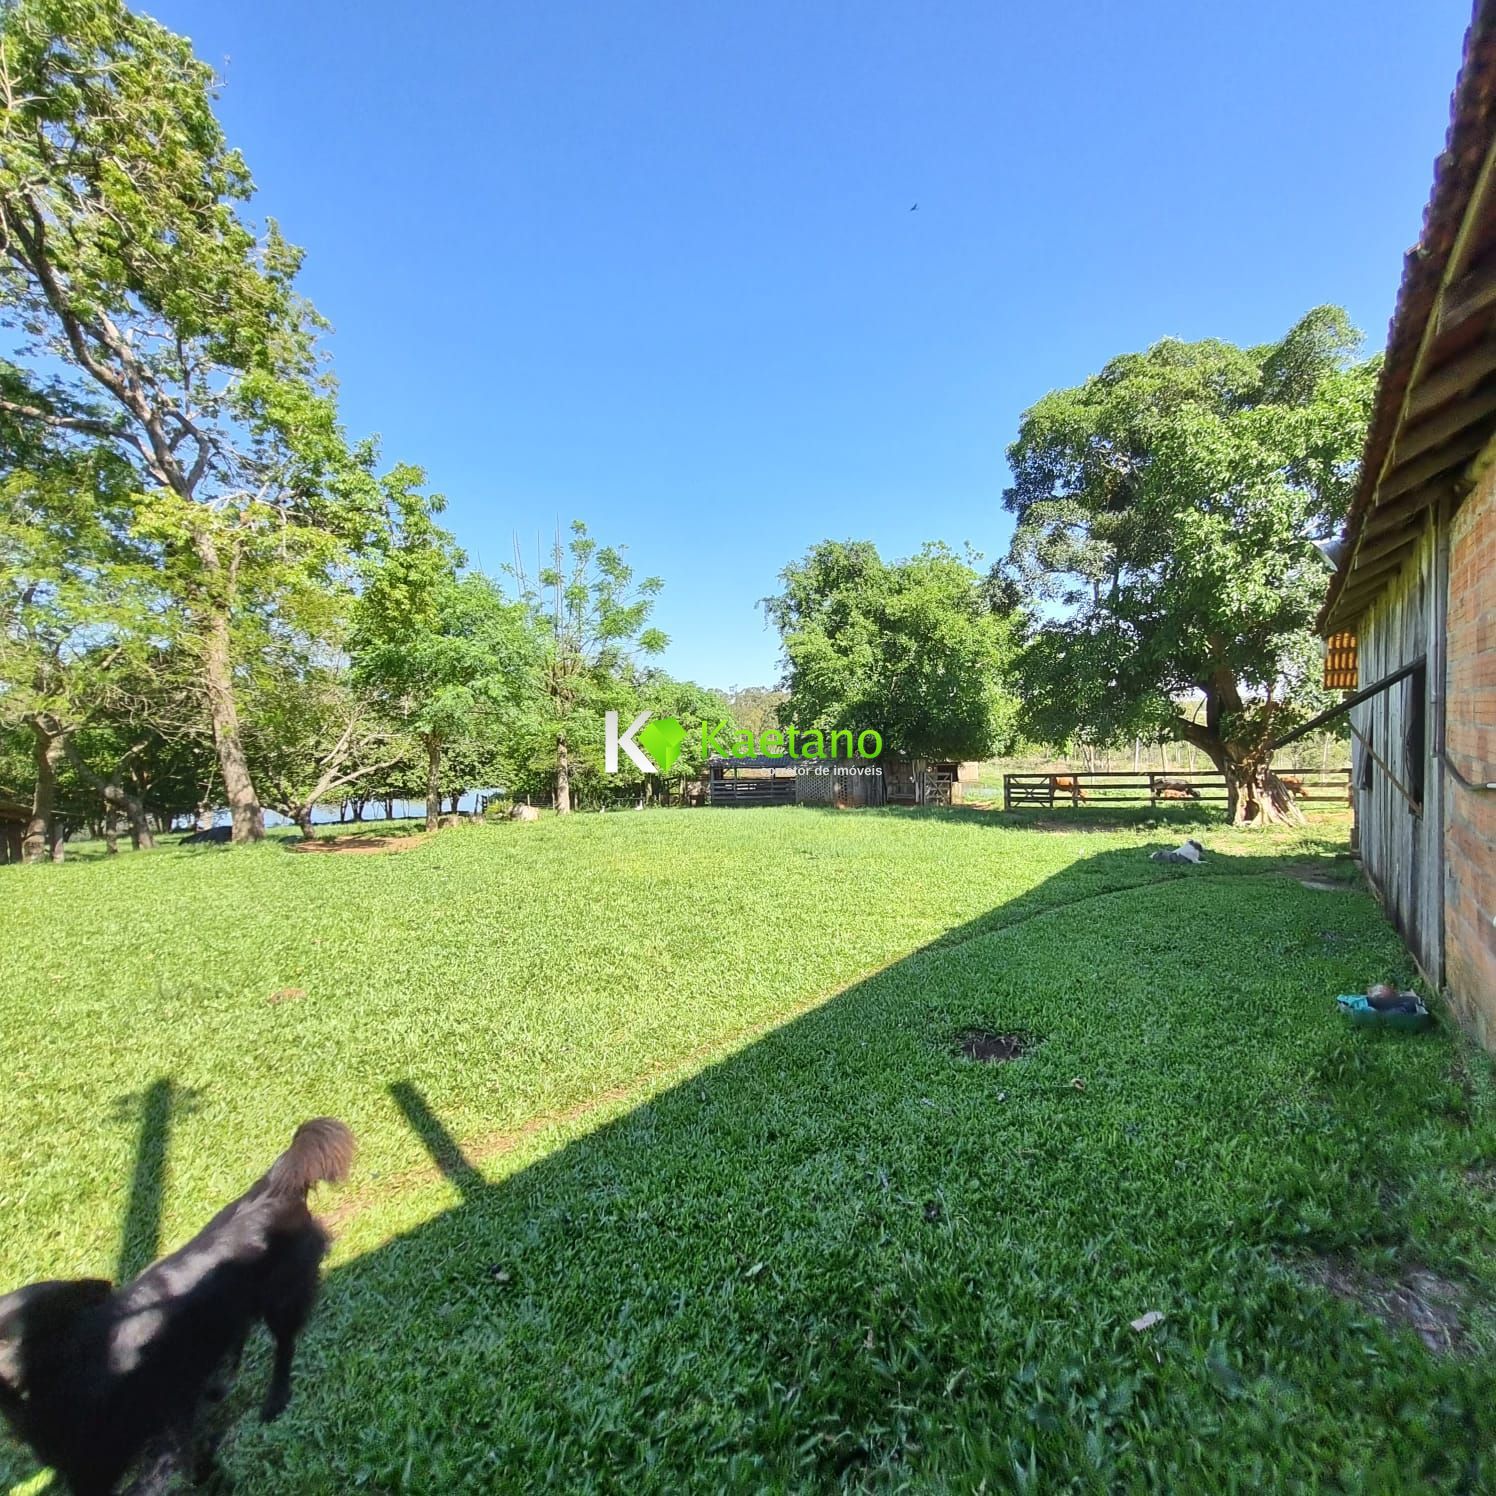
[0,0,379,841]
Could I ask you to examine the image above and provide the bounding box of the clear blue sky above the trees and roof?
[147,0,1469,687]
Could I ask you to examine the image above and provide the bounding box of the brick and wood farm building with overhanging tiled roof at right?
[1319,0,1496,1049]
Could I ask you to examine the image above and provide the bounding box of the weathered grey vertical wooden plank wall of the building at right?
[1351,516,1445,983]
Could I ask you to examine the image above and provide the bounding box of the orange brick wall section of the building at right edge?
[1444,468,1496,1050]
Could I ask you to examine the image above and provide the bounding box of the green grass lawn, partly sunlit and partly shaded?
[0,808,1496,1493]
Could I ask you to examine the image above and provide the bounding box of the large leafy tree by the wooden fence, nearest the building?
[1004,307,1375,821]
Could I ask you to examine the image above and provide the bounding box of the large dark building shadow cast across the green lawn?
[207,848,1496,1490]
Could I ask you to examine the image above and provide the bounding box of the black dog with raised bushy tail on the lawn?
[0,1118,353,1496]
